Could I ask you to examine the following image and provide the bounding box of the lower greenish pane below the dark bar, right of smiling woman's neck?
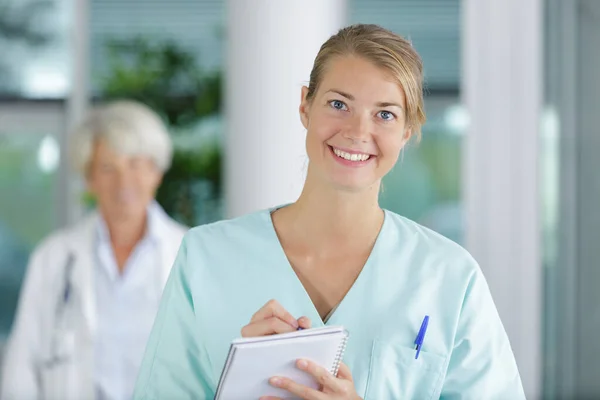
[380,96,467,243]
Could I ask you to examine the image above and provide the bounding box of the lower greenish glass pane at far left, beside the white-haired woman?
[0,130,60,342]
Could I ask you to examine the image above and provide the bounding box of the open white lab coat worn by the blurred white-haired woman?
[0,210,186,400]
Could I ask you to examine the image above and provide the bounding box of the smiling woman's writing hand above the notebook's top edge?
[242,300,311,337]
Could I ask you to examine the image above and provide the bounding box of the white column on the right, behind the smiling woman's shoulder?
[462,0,543,399]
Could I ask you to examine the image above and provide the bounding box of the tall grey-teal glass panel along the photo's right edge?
[540,0,600,399]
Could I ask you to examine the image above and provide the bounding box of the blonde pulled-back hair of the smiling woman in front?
[306,24,425,140]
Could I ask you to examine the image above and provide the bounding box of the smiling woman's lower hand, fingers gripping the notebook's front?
[260,360,360,400]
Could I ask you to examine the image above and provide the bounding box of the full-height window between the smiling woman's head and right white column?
[349,0,468,243]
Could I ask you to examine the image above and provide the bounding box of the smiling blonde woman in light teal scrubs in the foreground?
[135,25,524,400]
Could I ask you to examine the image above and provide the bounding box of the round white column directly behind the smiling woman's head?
[224,0,346,217]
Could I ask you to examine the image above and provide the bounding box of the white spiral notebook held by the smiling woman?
[215,326,348,400]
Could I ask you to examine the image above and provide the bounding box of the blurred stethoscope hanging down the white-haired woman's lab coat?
[43,253,75,368]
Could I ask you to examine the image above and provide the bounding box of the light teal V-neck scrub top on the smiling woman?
[134,210,525,400]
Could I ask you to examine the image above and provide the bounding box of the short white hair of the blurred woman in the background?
[71,100,173,175]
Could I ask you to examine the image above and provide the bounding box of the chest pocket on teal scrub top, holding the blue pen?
[365,339,446,400]
